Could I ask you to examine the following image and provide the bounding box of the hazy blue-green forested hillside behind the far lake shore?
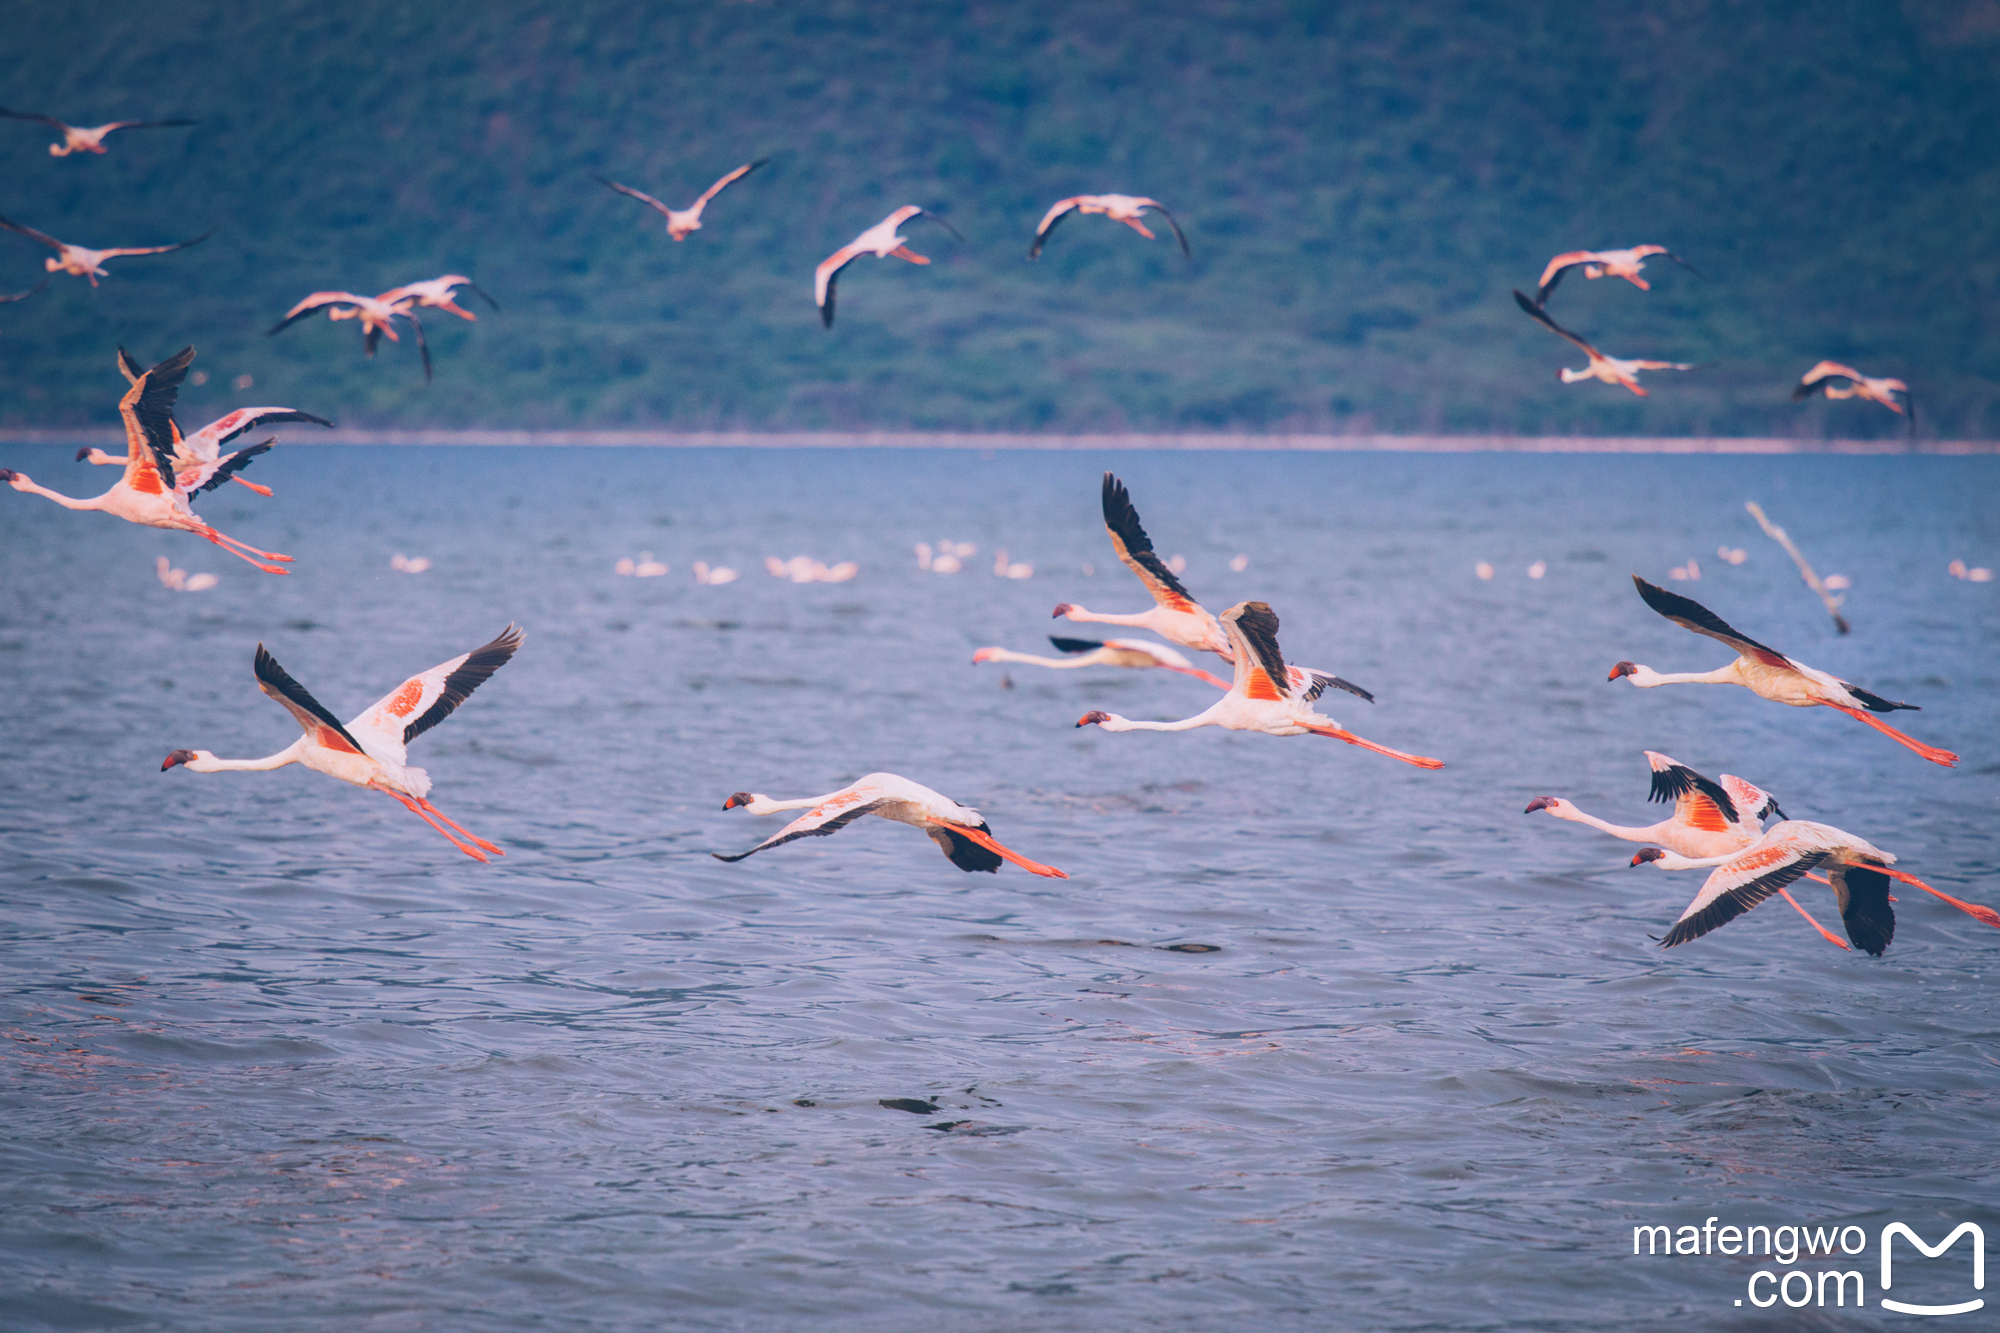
[0,0,2000,438]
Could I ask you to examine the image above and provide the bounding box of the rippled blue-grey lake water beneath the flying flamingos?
[0,446,2000,1331]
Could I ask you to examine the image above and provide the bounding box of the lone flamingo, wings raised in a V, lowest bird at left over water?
[160,624,522,861]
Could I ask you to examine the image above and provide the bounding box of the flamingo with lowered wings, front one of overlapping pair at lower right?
[1632,819,2000,957]
